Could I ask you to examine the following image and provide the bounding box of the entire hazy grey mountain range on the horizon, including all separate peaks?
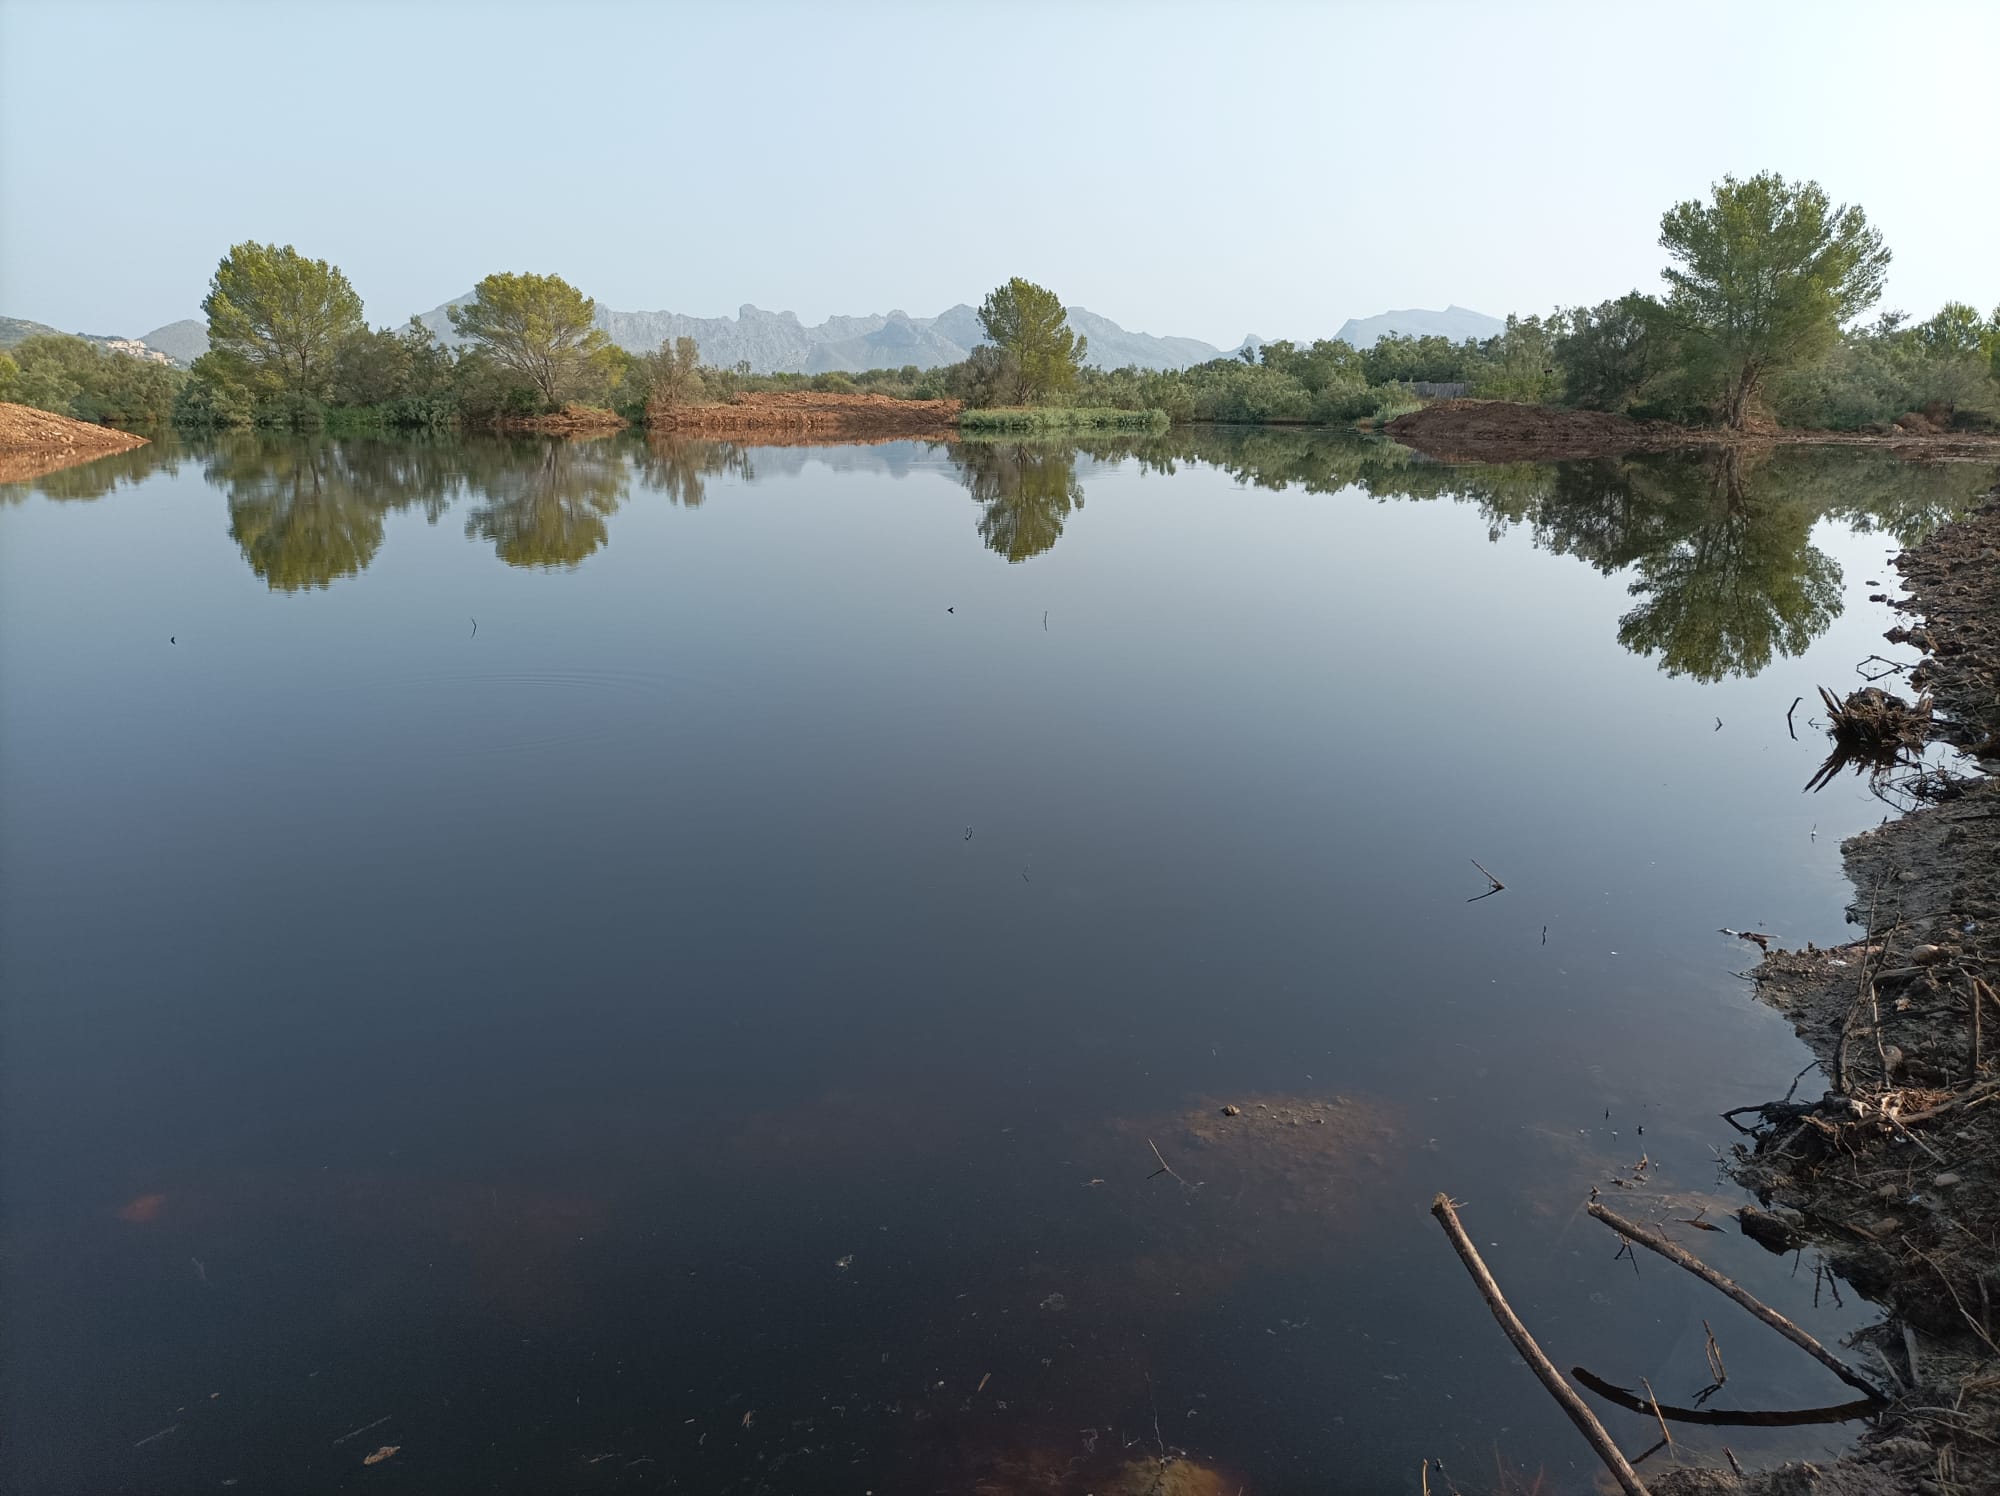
[0,292,1504,374]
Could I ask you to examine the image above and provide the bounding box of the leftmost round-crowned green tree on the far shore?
[202,240,366,400]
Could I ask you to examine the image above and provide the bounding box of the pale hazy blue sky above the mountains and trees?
[0,0,2000,344]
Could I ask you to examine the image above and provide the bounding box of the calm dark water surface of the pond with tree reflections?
[0,432,1996,1492]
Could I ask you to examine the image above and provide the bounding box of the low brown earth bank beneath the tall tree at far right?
[1384,400,2000,462]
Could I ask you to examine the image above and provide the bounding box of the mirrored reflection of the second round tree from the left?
[466,438,632,568]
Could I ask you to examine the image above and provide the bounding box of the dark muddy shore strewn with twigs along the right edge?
[1652,490,2000,1496]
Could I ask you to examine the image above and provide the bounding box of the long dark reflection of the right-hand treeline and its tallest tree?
[1086,428,1996,680]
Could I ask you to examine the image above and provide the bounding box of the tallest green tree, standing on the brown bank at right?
[1660,172,1890,428]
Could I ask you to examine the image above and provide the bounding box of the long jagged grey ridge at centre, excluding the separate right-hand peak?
[414,296,1220,374]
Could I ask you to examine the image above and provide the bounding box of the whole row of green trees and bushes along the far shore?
[0,174,2000,430]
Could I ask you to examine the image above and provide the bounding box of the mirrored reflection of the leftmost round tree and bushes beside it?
[208,436,460,592]
